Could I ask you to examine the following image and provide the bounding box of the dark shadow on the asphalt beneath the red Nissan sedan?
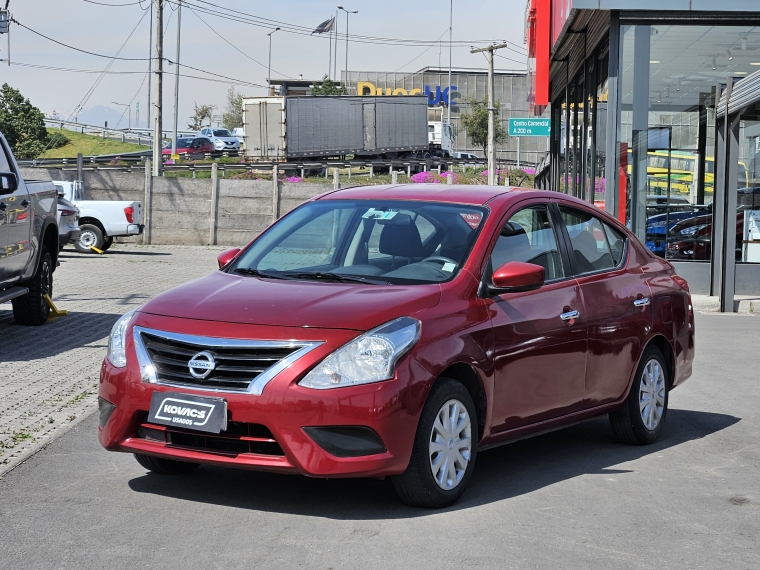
[129,410,740,520]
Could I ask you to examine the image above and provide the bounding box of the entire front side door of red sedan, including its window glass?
[486,203,587,432]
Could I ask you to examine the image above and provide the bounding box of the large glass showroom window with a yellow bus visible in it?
[618,24,760,261]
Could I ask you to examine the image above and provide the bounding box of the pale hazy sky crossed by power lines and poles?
[0,0,525,127]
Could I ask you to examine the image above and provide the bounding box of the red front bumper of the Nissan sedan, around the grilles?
[98,316,432,477]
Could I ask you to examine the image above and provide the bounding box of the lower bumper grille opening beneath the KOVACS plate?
[137,422,285,456]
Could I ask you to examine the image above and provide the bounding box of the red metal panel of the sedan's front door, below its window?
[489,280,587,432]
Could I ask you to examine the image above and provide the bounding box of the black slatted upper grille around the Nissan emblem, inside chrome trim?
[141,332,302,391]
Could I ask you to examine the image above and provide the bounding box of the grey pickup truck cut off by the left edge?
[0,133,58,325]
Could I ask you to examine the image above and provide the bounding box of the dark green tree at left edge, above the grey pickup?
[0,83,52,158]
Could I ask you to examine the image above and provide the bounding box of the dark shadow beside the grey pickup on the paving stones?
[0,310,125,363]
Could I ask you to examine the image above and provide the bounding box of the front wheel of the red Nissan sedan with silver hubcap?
[393,378,478,509]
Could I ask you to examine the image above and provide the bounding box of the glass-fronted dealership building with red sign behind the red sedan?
[527,0,760,310]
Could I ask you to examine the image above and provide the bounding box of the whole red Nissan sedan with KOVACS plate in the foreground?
[99,184,694,507]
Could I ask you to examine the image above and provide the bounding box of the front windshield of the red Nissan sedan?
[228,200,487,284]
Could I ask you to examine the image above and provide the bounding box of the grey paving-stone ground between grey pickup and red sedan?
[0,244,225,477]
